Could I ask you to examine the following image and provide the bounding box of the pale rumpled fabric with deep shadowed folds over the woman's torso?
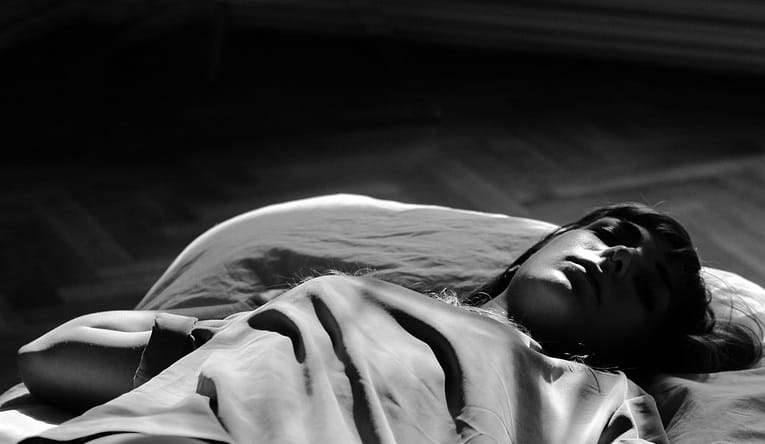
[26,276,668,444]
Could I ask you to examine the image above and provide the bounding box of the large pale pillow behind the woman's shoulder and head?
[136,194,765,354]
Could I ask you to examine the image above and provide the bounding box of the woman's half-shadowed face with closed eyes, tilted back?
[490,217,672,360]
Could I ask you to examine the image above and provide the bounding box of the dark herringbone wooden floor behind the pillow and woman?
[0,24,765,389]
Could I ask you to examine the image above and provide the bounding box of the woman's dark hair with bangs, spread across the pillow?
[461,203,762,379]
